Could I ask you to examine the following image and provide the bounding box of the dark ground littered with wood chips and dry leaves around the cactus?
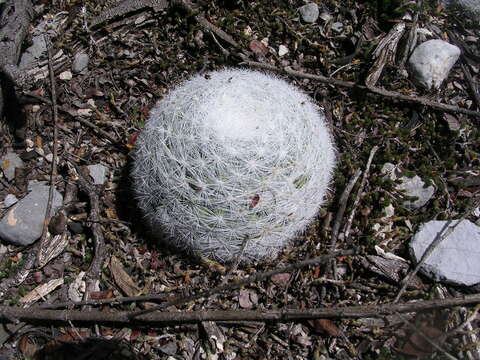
[0,0,480,359]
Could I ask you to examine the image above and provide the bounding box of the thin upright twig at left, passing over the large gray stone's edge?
[36,36,58,266]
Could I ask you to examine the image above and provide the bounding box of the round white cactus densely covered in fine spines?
[132,69,335,262]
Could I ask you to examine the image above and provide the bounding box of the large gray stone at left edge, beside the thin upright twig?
[0,183,63,246]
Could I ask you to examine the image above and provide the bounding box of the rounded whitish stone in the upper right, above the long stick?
[409,39,460,89]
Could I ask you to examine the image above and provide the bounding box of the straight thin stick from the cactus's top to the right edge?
[244,60,480,118]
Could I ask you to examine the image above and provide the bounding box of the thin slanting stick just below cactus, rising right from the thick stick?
[128,250,357,319]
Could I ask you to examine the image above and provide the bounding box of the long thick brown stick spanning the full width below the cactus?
[0,294,480,326]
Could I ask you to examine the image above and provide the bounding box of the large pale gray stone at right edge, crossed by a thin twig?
[410,220,480,286]
